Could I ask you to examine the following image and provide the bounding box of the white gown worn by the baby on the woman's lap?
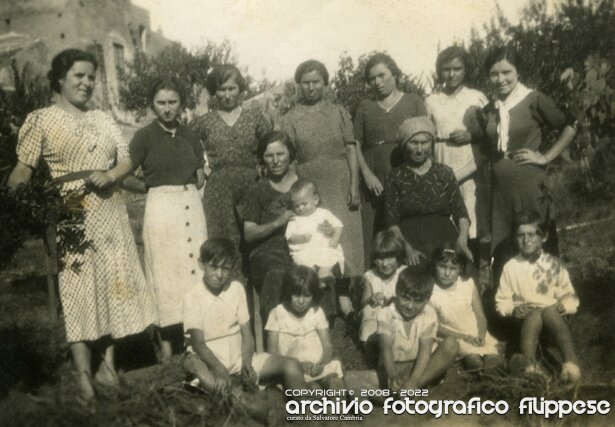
[286,208,344,273]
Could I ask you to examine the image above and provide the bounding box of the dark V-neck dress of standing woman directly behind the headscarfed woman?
[354,93,427,265]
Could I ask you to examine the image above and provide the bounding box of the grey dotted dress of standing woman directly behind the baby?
[281,101,364,276]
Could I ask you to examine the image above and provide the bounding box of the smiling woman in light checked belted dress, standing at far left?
[8,49,156,400]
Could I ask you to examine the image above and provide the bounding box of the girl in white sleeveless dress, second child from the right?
[431,245,503,370]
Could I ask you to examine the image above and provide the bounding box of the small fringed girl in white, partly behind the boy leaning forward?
[359,230,406,369]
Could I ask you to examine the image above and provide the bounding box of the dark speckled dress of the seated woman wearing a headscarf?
[384,162,468,266]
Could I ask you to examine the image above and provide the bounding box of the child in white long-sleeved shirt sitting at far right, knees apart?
[495,212,581,382]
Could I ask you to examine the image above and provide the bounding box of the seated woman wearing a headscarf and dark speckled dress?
[384,116,472,266]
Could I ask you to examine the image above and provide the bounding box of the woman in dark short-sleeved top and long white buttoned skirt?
[129,80,207,360]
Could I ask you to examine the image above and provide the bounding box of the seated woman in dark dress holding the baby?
[238,131,298,322]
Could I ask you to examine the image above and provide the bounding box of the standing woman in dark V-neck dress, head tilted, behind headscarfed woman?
[354,53,427,265]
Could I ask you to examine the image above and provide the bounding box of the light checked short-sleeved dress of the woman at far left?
[17,106,156,342]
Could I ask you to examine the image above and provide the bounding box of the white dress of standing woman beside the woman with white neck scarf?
[425,86,488,239]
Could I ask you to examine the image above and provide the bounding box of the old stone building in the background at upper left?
[0,0,179,111]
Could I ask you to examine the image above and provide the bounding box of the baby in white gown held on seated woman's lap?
[286,179,344,278]
